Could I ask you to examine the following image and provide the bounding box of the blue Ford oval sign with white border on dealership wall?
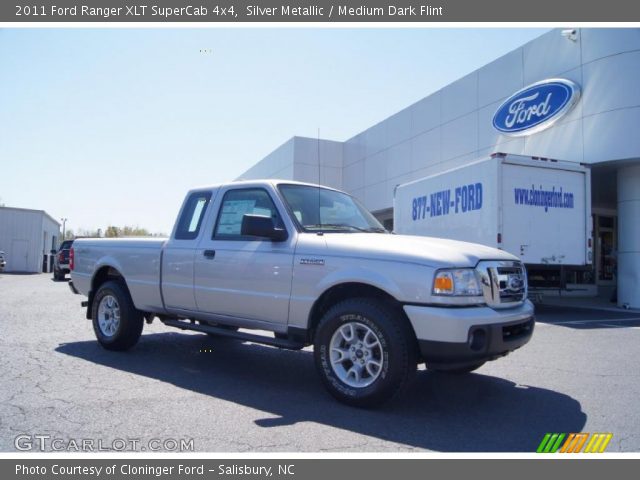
[493,78,580,137]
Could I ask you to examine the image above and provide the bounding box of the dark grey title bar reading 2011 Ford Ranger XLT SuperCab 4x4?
[0,0,640,23]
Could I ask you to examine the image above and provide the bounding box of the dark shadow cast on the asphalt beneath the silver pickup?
[56,333,587,452]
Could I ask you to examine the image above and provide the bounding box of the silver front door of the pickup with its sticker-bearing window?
[194,187,295,324]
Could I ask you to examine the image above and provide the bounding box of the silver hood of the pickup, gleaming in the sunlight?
[323,233,519,268]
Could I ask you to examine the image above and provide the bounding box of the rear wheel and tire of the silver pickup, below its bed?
[91,281,144,350]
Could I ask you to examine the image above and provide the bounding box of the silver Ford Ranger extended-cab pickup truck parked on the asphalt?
[70,180,534,407]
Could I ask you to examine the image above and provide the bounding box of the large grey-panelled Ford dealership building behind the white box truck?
[239,28,640,308]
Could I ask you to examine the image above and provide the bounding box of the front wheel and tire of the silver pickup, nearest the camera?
[314,298,417,407]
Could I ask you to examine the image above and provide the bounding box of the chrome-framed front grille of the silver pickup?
[476,260,527,308]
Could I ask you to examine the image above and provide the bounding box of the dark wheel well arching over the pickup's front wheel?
[308,282,415,342]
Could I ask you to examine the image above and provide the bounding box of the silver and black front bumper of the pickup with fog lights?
[404,301,535,364]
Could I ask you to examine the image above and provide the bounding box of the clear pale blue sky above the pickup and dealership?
[0,28,545,233]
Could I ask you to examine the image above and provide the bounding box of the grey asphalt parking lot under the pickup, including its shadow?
[0,274,640,452]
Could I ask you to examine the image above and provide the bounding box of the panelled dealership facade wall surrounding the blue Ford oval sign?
[343,29,640,211]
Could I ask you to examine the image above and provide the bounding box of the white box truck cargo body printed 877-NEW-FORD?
[393,153,592,266]
